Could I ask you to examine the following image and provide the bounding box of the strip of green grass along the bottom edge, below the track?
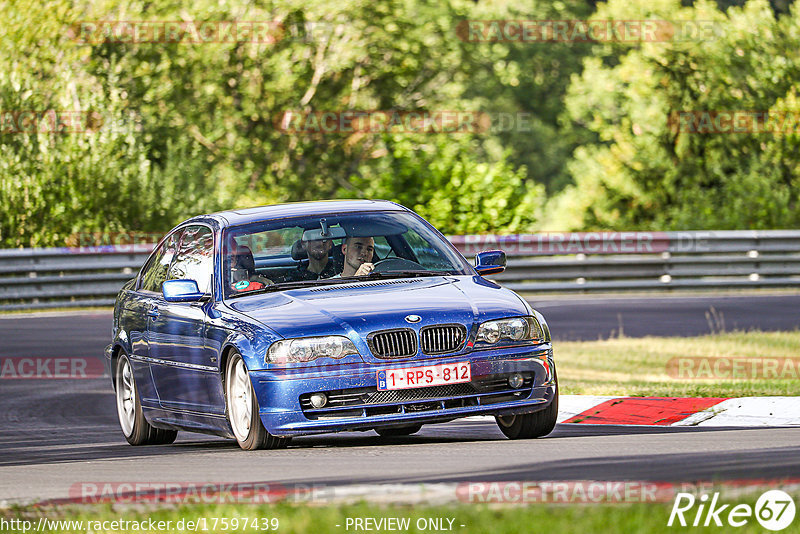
[0,497,788,534]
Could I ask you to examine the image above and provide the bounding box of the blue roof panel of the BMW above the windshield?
[191,200,410,227]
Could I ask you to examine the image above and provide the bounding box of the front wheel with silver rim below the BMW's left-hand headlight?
[225,352,291,451]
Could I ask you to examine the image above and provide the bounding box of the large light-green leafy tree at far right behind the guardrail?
[550,0,800,230]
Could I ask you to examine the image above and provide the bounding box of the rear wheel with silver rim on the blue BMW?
[114,353,178,445]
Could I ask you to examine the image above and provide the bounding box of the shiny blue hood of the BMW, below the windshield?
[228,276,528,359]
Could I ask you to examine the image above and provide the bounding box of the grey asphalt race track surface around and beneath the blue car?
[0,295,800,502]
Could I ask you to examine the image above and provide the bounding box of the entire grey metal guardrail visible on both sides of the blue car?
[0,230,800,310]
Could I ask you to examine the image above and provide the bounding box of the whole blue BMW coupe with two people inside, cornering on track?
[105,200,558,449]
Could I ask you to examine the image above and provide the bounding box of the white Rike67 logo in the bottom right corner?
[667,490,795,531]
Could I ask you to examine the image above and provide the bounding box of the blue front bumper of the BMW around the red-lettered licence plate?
[250,344,557,436]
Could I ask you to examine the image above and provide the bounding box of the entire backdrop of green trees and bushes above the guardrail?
[0,0,800,247]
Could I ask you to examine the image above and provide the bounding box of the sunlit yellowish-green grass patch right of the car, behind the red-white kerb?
[554,331,800,397]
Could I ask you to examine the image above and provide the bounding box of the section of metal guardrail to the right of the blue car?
[451,230,800,292]
